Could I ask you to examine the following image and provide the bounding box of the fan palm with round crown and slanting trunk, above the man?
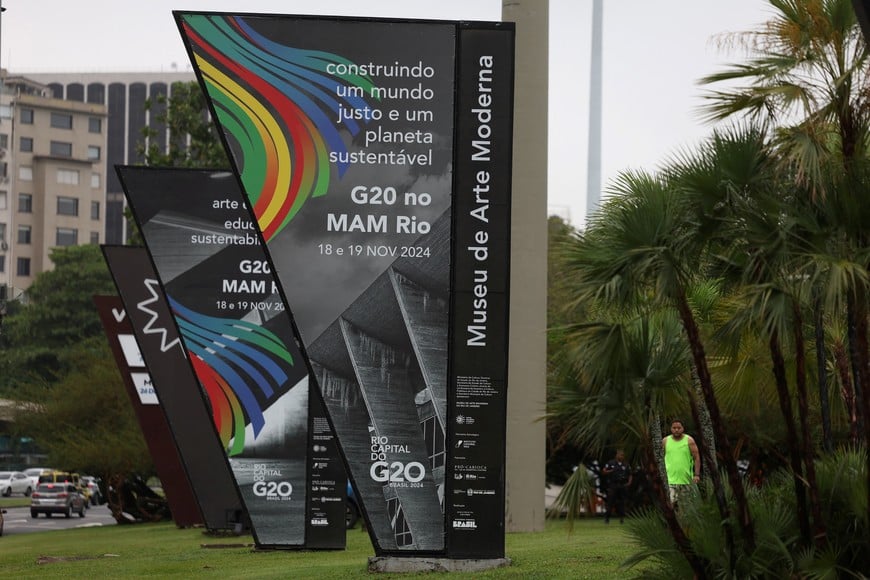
[565,162,755,552]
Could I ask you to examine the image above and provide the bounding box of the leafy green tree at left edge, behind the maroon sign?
[0,245,165,521]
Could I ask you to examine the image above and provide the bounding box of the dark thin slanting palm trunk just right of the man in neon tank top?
[676,288,755,554]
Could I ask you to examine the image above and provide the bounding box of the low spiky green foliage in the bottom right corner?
[626,450,870,580]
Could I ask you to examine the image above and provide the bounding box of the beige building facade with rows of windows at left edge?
[0,75,106,300]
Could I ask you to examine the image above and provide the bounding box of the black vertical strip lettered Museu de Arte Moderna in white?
[447,29,514,558]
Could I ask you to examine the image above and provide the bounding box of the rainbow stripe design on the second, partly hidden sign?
[167,297,293,456]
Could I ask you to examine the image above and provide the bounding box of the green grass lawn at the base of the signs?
[0,519,656,580]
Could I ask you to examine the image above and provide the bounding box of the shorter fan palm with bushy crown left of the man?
[548,300,716,577]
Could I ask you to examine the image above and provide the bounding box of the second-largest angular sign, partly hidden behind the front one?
[117,167,346,549]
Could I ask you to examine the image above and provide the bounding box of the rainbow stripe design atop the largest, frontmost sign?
[181,15,373,242]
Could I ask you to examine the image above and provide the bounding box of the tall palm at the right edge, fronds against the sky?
[701,0,870,533]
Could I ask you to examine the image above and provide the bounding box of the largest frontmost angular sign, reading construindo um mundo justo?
[176,12,514,558]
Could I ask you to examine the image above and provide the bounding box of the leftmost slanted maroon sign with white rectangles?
[94,292,204,528]
